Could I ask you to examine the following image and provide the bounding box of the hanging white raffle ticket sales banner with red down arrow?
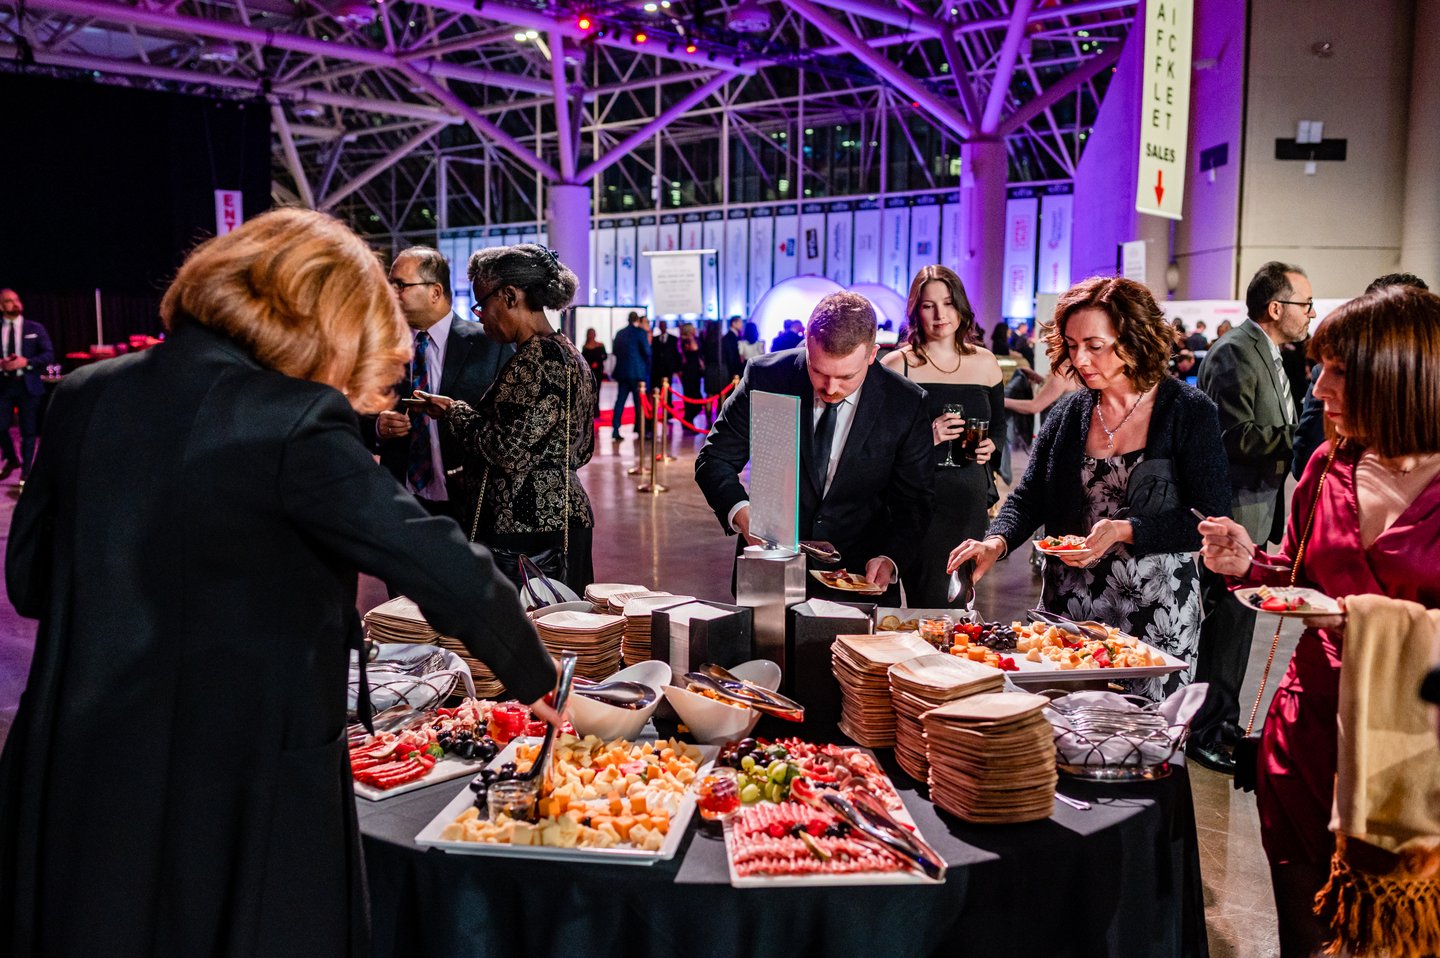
[1135,0,1195,219]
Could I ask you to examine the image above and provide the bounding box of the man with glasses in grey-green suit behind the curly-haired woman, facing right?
[1187,262,1315,774]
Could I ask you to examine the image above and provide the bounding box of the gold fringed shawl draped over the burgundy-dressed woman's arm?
[1315,595,1440,958]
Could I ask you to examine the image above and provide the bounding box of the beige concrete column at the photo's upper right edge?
[1400,0,1440,284]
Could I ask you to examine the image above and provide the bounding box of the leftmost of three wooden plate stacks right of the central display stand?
[829,632,935,749]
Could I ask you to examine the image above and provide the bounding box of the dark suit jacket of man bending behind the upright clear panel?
[696,349,935,587]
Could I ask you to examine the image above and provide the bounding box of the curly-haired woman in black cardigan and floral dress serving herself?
[949,277,1228,702]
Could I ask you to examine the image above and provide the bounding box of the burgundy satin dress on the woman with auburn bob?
[1246,444,1440,864]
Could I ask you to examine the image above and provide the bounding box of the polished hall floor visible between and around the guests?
[0,400,1295,958]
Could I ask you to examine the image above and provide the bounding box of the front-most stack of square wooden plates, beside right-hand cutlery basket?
[923,691,1057,824]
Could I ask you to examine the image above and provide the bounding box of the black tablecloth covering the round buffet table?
[357,752,1208,958]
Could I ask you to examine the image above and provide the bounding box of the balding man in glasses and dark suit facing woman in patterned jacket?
[372,246,516,526]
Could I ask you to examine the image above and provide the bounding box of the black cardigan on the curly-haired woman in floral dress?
[985,379,1230,556]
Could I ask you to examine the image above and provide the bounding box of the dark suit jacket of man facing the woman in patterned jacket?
[366,315,516,503]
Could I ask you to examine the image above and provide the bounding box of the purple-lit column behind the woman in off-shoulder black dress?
[956,140,1009,333]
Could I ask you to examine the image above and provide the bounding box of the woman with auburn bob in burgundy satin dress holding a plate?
[1200,287,1440,958]
